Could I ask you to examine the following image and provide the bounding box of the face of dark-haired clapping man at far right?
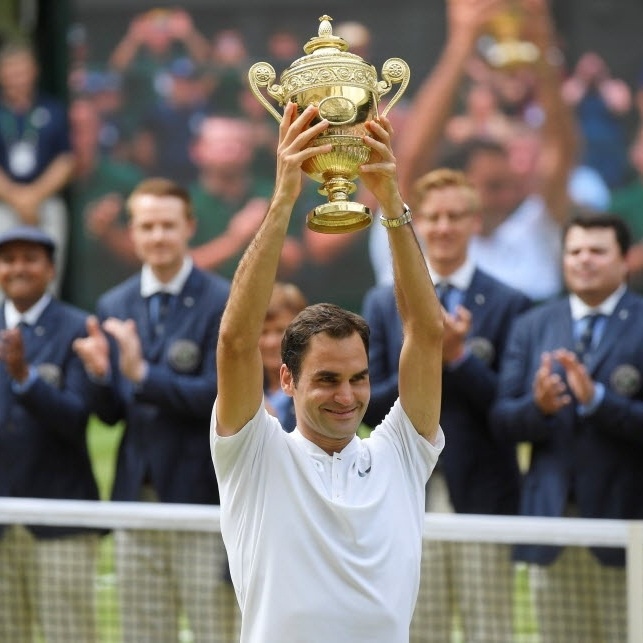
[563,226,627,306]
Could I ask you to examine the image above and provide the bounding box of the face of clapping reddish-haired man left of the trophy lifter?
[130,193,195,282]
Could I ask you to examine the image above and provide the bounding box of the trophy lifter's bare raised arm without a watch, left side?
[216,103,331,435]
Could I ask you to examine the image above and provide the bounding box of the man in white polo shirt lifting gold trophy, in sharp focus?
[211,104,444,643]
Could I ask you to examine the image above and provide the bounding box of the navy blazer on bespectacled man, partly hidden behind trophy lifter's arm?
[363,270,531,514]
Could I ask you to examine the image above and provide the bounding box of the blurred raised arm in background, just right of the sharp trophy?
[396,0,505,195]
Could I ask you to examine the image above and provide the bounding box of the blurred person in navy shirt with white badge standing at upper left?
[0,42,74,291]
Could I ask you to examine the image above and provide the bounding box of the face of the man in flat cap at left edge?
[0,241,55,312]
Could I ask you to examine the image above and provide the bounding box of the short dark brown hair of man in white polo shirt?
[281,304,370,384]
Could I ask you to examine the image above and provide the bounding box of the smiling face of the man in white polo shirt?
[281,332,370,454]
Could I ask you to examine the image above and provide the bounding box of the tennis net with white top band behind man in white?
[0,498,643,643]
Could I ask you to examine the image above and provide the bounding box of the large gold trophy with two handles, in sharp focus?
[248,16,410,233]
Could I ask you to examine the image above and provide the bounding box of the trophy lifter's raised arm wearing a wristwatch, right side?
[361,118,443,441]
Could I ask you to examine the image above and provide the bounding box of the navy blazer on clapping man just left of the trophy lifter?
[94,268,229,504]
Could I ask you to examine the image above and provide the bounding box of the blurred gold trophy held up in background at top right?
[481,0,540,70]
